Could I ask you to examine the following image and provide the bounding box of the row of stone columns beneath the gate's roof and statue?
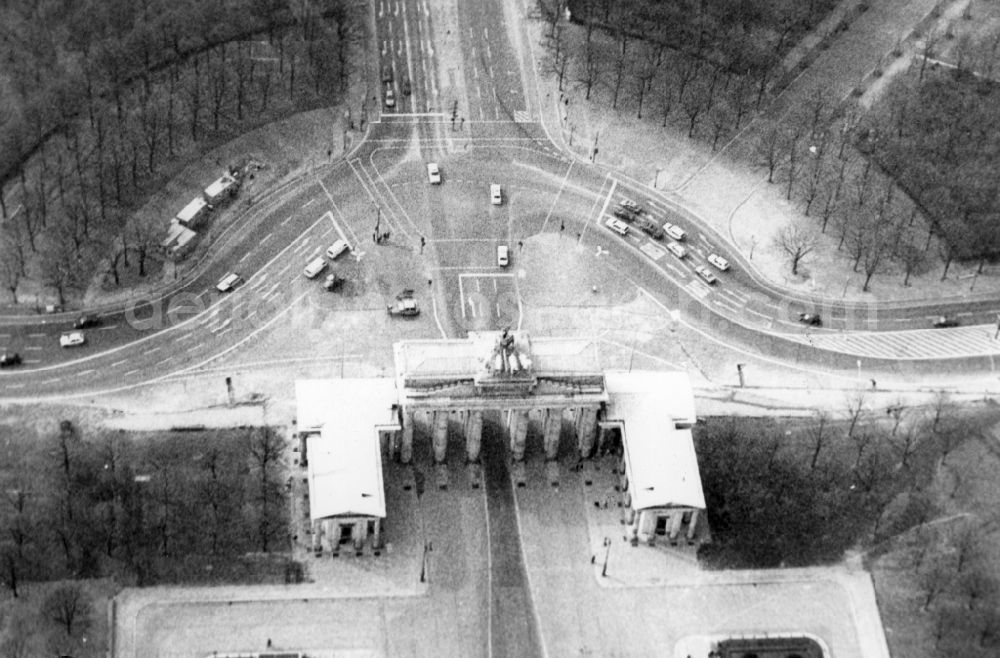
[394,406,600,464]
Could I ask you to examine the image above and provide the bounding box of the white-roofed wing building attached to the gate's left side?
[295,379,400,555]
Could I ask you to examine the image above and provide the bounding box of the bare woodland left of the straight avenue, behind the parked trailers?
[0,0,364,303]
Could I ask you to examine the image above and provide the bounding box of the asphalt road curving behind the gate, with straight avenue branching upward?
[0,0,1000,397]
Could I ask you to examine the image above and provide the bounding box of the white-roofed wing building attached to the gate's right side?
[599,371,708,544]
